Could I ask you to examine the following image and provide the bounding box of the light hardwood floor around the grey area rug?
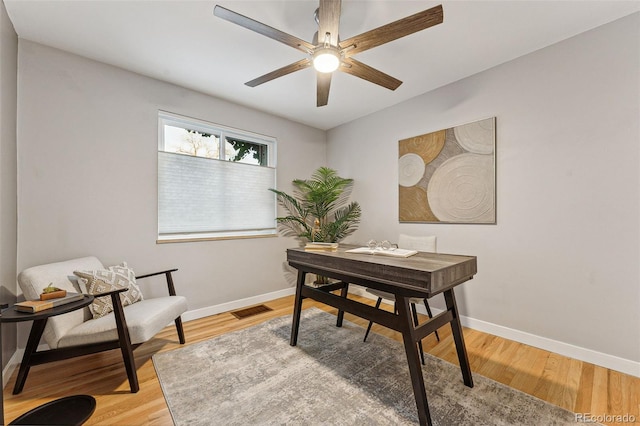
[4,295,640,425]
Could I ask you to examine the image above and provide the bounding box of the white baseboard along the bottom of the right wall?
[349,286,640,377]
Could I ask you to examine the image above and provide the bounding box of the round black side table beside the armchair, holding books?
[0,295,96,425]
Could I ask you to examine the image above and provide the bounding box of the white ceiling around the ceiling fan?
[4,0,640,129]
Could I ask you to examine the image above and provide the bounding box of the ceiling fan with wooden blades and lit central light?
[213,0,443,107]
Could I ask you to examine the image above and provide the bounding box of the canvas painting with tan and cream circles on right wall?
[398,117,496,224]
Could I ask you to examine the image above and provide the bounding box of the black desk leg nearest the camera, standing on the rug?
[396,296,431,426]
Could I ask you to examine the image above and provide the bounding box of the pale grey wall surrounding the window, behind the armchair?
[17,40,326,310]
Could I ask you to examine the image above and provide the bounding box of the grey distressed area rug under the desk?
[153,308,576,426]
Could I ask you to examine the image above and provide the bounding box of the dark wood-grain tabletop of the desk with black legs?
[287,244,477,295]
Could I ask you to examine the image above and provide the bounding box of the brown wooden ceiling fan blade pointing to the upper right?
[340,5,444,57]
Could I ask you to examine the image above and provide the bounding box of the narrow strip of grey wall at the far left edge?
[0,2,18,368]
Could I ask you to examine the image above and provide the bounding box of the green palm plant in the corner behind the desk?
[269,167,361,243]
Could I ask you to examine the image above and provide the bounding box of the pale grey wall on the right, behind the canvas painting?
[328,13,640,375]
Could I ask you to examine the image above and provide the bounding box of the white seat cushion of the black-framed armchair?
[57,296,187,348]
